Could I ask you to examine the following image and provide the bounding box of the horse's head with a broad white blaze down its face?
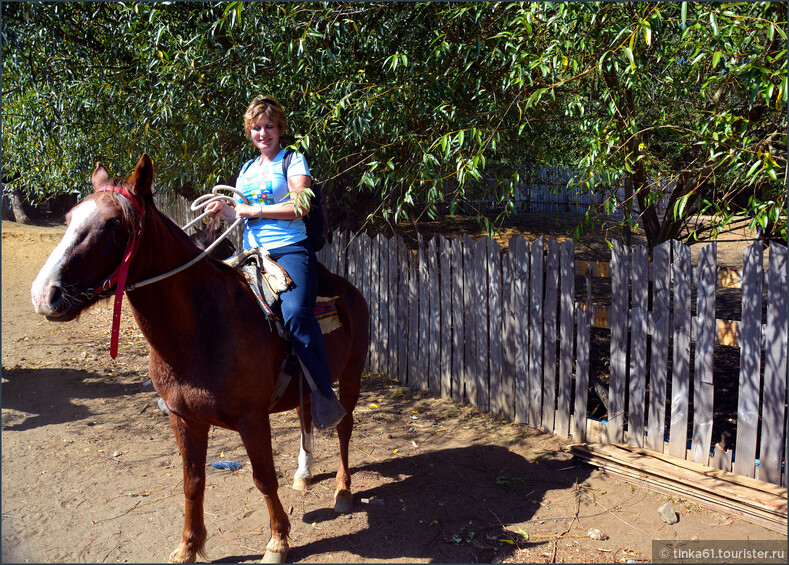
[31,155,153,321]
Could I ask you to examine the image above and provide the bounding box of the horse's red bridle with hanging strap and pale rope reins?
[82,185,246,359]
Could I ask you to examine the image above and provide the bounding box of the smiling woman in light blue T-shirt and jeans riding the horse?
[206,96,345,429]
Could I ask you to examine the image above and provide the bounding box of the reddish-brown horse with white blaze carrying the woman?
[32,155,369,562]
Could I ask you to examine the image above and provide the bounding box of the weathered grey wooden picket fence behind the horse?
[319,231,789,485]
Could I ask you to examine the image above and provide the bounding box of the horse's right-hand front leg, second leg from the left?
[239,414,290,563]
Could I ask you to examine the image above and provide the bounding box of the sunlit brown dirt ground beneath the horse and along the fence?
[2,214,785,563]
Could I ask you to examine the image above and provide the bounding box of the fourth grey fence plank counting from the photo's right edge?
[668,241,691,459]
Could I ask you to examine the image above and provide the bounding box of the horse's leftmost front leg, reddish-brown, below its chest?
[169,410,210,563]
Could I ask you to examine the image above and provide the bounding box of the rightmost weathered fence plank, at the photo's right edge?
[759,242,789,484]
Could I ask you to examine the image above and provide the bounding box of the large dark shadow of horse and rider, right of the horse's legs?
[212,445,592,563]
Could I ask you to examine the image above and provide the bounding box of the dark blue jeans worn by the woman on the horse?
[269,239,332,396]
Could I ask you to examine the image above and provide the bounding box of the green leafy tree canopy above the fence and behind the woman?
[2,2,789,244]
